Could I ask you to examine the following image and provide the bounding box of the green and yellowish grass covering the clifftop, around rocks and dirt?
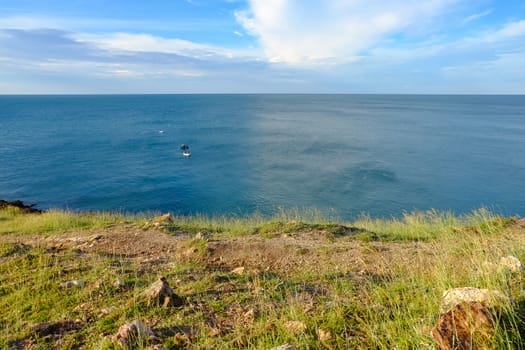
[0,208,525,349]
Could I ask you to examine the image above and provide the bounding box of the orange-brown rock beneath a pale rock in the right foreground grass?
[430,301,494,350]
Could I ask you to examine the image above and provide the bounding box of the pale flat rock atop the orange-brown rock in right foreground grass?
[440,287,510,313]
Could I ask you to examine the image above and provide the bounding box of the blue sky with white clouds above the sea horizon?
[0,0,525,94]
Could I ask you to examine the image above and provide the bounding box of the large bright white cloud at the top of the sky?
[236,0,458,64]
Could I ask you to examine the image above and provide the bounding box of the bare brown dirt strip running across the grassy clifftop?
[2,224,432,274]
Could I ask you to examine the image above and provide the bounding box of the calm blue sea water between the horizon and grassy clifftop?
[0,95,525,219]
